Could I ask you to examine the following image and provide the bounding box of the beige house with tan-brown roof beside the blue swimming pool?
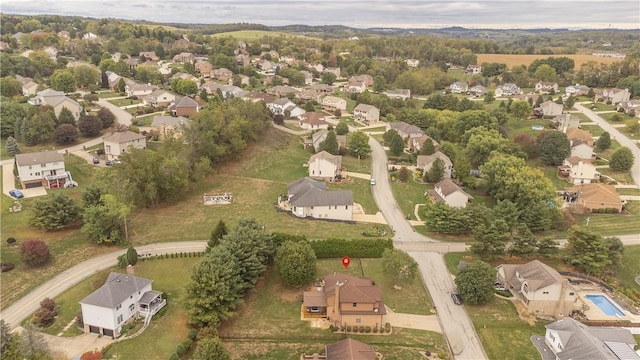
[497,260,582,318]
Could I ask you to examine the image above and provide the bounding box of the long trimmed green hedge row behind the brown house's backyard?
[309,238,393,258]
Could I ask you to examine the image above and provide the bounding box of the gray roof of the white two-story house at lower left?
[80,272,151,309]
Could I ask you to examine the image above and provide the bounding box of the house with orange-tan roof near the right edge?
[566,183,624,212]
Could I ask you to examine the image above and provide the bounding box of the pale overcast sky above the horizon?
[0,0,640,29]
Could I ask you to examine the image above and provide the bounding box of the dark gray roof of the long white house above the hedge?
[288,177,353,207]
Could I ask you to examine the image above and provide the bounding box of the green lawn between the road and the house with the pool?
[465,298,547,360]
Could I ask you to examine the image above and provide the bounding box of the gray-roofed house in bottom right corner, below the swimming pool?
[544,317,640,360]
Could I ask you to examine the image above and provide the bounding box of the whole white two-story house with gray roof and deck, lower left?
[80,272,167,338]
